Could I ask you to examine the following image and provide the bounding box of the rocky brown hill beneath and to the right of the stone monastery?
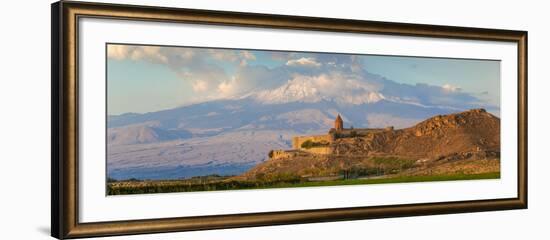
[239,109,500,179]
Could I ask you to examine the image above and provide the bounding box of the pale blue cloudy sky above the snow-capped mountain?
[107,44,500,115]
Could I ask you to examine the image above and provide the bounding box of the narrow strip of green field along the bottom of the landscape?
[107,172,500,195]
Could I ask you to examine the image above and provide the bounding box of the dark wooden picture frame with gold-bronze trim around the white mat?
[51,1,527,239]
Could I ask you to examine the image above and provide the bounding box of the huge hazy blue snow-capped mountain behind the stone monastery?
[107,71,498,179]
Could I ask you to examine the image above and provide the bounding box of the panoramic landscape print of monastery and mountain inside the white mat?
[105,43,501,195]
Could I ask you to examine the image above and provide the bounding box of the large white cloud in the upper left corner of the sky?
[107,44,263,98]
